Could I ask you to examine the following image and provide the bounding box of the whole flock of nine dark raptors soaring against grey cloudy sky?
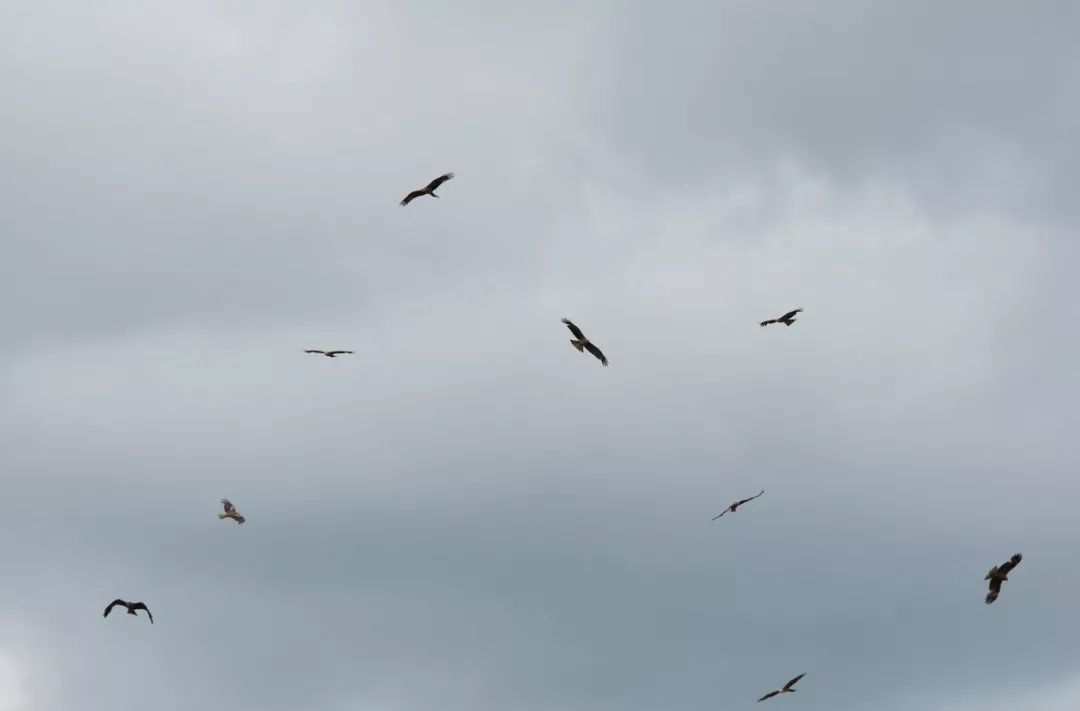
[97,173,1023,701]
